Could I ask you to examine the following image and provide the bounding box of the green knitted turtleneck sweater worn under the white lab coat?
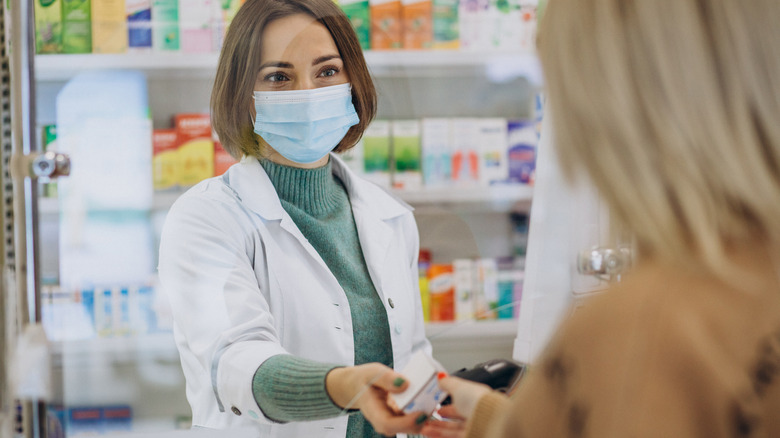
[252,160,393,438]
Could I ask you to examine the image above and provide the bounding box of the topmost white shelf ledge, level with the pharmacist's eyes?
[34,50,541,82]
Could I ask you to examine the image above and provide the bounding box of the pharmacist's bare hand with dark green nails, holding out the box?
[325,363,428,436]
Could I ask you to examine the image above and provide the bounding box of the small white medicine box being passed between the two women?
[391,351,447,415]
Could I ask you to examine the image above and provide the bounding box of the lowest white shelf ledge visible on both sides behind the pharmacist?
[51,319,517,364]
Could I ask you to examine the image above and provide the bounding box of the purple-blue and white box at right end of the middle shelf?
[507,120,538,184]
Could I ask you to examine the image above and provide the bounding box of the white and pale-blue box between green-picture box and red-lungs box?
[420,118,452,187]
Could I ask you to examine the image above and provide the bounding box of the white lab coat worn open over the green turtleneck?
[159,154,431,437]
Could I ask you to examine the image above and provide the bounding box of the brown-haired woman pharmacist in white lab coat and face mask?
[159,0,430,437]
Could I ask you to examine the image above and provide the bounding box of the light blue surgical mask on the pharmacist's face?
[254,83,360,164]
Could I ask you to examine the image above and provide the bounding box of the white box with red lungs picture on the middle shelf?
[450,118,480,186]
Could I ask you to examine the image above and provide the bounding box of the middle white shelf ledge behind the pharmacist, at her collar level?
[38,184,533,215]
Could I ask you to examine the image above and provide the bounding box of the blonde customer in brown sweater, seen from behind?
[423,0,780,438]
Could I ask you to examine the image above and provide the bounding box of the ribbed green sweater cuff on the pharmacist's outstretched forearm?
[252,354,343,423]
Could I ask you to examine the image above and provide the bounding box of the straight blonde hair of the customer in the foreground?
[538,0,780,272]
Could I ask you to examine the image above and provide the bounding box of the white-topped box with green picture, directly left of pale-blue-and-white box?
[390,119,422,190]
